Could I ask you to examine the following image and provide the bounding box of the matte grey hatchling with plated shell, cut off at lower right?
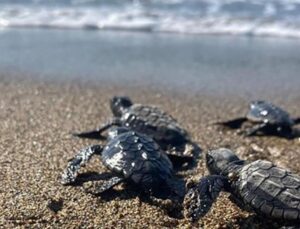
[184,148,300,223]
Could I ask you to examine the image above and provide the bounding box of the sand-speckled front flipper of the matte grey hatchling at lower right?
[184,175,228,222]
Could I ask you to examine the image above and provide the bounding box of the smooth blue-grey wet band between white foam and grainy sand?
[0,29,300,102]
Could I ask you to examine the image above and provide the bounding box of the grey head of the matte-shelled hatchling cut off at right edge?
[206,148,241,174]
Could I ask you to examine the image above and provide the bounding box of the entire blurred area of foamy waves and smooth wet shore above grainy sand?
[0,0,300,97]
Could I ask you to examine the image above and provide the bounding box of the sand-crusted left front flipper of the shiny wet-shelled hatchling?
[61,145,103,185]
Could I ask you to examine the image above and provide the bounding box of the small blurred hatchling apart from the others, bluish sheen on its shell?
[218,101,300,138]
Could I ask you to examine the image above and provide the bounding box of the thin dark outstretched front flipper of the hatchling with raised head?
[72,118,121,140]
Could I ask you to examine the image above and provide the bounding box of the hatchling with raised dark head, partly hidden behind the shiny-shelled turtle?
[74,97,201,167]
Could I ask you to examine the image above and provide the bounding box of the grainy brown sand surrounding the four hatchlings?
[0,78,300,228]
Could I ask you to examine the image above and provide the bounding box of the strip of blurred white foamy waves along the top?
[0,0,300,38]
